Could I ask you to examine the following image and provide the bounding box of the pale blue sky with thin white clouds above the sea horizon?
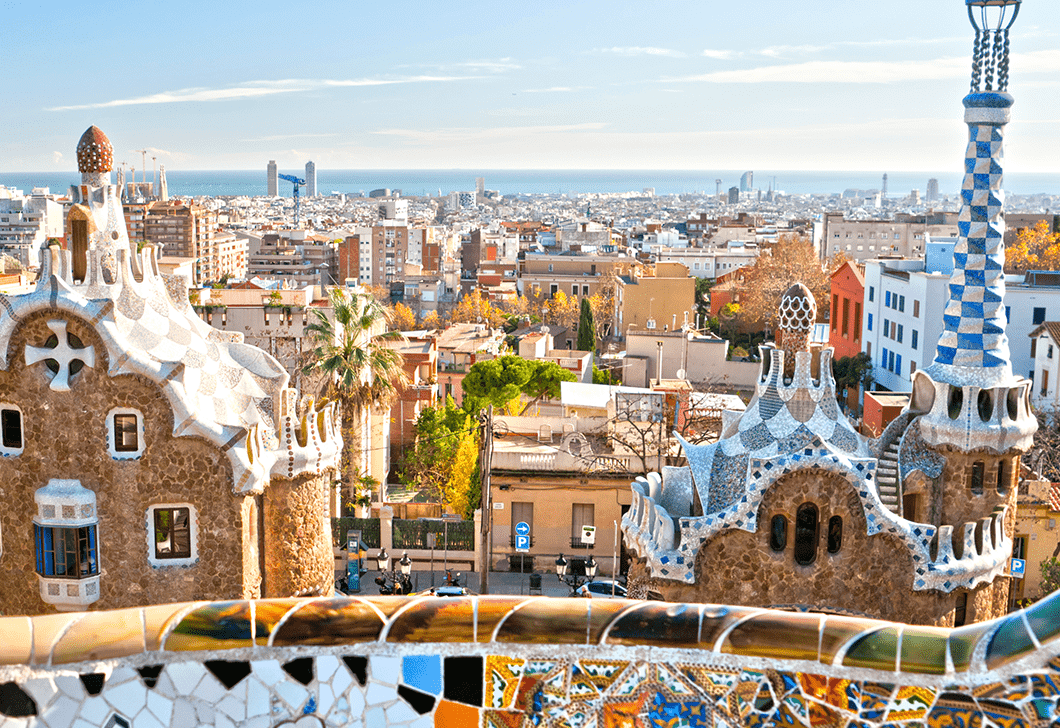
[0,0,1060,173]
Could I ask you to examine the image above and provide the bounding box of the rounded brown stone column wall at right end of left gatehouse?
[263,472,335,597]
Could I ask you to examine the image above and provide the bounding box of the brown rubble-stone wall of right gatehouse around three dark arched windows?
[630,469,1008,626]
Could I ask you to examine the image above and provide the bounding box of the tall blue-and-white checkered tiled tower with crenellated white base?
[911,0,1037,454]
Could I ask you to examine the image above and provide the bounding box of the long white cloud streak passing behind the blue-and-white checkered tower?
[659,50,1060,84]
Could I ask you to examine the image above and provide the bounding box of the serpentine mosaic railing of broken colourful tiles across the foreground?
[0,596,1060,728]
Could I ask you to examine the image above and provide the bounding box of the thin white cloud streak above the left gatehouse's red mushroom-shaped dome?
[46,75,478,111]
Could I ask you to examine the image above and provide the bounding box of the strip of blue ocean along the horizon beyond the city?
[0,166,1060,198]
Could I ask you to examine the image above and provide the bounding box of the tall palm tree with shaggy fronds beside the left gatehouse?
[301,288,408,499]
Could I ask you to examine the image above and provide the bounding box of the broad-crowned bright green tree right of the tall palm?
[461,355,578,412]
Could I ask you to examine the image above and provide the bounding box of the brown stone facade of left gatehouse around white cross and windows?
[0,312,257,615]
